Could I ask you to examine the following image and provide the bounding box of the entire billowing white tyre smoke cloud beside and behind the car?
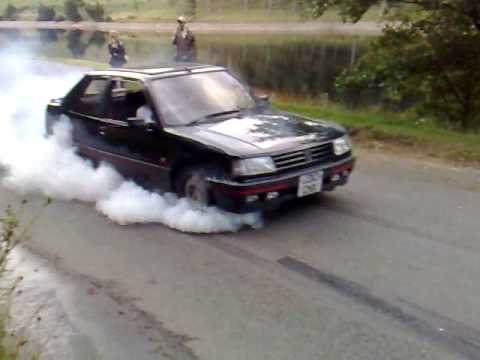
[0,49,261,233]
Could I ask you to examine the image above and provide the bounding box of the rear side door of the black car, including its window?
[65,77,110,160]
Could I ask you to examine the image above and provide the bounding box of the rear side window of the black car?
[71,79,109,117]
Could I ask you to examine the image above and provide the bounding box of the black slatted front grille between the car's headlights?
[272,142,335,171]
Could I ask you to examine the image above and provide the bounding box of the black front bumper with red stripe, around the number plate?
[208,157,355,213]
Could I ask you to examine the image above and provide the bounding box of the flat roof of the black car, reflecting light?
[87,63,226,81]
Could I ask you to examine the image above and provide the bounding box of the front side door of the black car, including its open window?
[102,79,169,187]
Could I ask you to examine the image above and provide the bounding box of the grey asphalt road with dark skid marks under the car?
[0,153,480,360]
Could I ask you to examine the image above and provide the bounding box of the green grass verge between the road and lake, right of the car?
[276,102,480,168]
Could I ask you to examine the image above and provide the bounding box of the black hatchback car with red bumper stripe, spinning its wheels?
[46,64,354,213]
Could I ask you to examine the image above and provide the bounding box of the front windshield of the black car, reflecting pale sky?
[152,71,255,126]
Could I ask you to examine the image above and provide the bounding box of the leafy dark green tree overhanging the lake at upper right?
[302,0,480,130]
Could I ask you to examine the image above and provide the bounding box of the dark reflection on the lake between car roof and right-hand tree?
[212,40,362,98]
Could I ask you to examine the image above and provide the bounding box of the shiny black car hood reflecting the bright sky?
[165,113,345,157]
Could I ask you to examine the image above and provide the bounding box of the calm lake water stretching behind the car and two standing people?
[0,30,369,100]
